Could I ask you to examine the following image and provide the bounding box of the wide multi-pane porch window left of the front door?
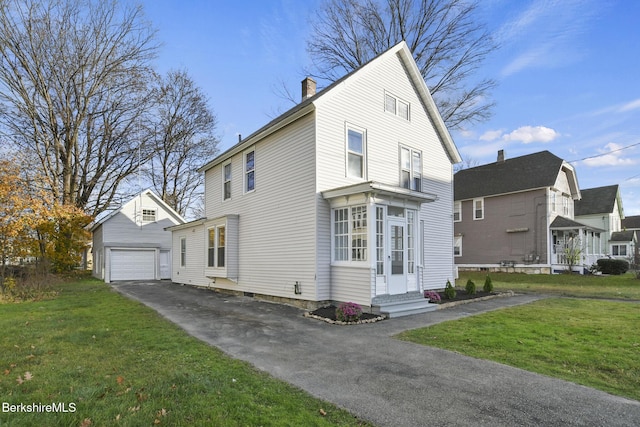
[333,205,367,261]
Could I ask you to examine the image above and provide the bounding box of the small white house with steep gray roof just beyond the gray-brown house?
[575,184,624,257]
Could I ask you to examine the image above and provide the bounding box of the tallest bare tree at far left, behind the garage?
[0,0,157,215]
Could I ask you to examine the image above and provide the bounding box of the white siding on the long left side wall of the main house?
[199,114,316,300]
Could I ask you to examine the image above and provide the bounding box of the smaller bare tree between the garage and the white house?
[146,71,218,219]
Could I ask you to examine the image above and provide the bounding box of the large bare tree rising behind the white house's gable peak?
[307,0,496,129]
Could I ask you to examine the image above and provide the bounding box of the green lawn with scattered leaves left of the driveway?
[0,280,368,426]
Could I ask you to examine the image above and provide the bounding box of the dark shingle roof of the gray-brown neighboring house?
[453,150,563,200]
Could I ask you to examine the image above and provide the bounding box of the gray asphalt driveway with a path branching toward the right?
[112,282,640,427]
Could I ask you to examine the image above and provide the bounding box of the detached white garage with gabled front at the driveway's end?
[90,190,185,283]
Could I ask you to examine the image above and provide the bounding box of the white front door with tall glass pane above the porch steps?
[387,218,407,295]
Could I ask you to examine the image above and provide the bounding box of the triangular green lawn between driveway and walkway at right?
[398,298,640,400]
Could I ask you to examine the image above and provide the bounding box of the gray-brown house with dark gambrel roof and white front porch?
[453,150,603,273]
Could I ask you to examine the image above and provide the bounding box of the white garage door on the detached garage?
[110,249,156,281]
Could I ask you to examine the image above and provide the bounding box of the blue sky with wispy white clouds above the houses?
[143,0,640,215]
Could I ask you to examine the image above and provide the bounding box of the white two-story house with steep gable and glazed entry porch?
[170,42,461,315]
